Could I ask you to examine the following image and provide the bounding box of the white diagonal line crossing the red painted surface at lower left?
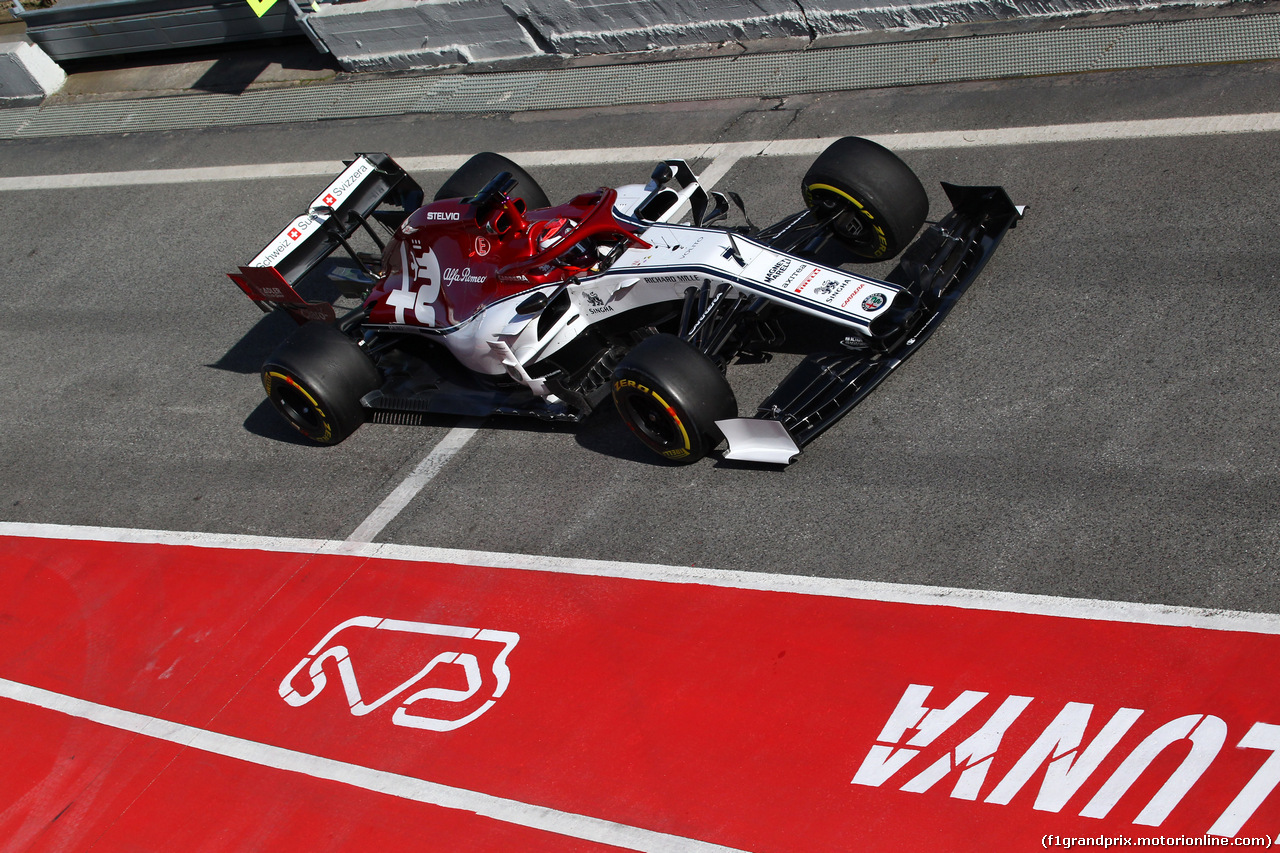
[0,679,740,853]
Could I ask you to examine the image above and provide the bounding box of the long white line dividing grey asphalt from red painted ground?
[0,521,1280,634]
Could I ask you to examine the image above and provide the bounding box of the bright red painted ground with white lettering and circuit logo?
[0,538,1280,853]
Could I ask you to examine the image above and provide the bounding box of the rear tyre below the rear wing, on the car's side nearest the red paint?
[262,323,381,444]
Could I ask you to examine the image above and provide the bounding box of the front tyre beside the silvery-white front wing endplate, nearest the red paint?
[613,334,737,465]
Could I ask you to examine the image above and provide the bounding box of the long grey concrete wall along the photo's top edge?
[303,0,1233,70]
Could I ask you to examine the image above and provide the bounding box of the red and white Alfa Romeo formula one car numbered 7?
[230,137,1023,465]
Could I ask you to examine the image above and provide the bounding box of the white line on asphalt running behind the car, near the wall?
[0,113,1280,191]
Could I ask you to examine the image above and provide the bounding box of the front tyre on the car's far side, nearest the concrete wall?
[800,136,929,261]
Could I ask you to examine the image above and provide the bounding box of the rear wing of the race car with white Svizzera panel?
[228,154,422,324]
